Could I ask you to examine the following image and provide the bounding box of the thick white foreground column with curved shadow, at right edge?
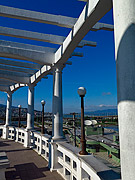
[113,0,135,180]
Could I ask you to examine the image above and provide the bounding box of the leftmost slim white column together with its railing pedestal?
[3,92,12,139]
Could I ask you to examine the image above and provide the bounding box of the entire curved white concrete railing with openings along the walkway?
[0,126,120,180]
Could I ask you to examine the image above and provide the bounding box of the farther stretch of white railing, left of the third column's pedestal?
[0,126,50,161]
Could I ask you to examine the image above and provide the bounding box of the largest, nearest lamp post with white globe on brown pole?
[77,87,88,155]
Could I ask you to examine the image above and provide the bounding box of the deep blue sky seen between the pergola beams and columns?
[0,0,117,113]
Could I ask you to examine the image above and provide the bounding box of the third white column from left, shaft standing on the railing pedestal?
[52,66,63,140]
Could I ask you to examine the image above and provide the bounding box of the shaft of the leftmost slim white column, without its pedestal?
[6,93,12,126]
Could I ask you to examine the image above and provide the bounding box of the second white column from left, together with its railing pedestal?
[24,85,34,147]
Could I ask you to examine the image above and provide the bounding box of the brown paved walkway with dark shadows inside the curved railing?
[0,138,63,180]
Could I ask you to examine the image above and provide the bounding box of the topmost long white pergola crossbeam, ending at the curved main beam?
[0,5,77,28]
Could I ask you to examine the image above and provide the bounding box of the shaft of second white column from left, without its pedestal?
[26,86,34,130]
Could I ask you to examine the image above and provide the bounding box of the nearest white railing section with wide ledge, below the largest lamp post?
[56,142,120,180]
